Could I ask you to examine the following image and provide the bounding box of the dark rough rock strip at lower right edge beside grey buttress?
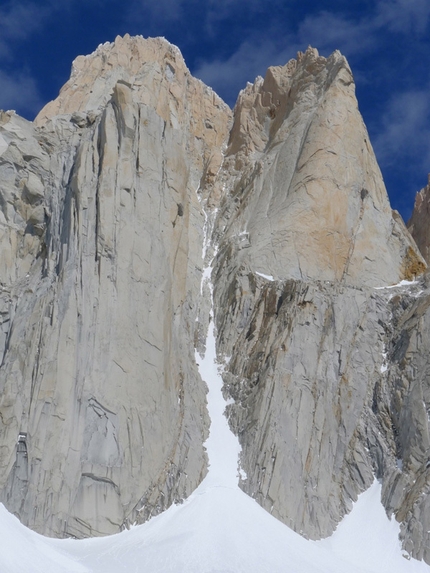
[378,273,430,563]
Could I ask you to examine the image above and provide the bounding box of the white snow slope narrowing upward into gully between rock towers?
[0,262,430,573]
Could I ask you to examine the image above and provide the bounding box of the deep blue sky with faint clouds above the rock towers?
[0,0,430,219]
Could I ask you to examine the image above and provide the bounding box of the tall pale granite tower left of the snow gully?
[0,34,230,536]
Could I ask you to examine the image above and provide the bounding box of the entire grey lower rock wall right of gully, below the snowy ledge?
[214,272,430,561]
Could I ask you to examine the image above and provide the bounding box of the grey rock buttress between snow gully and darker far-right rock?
[215,274,382,539]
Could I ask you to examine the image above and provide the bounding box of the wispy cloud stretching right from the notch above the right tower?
[194,0,430,99]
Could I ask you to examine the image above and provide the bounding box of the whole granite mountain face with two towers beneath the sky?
[0,36,430,563]
